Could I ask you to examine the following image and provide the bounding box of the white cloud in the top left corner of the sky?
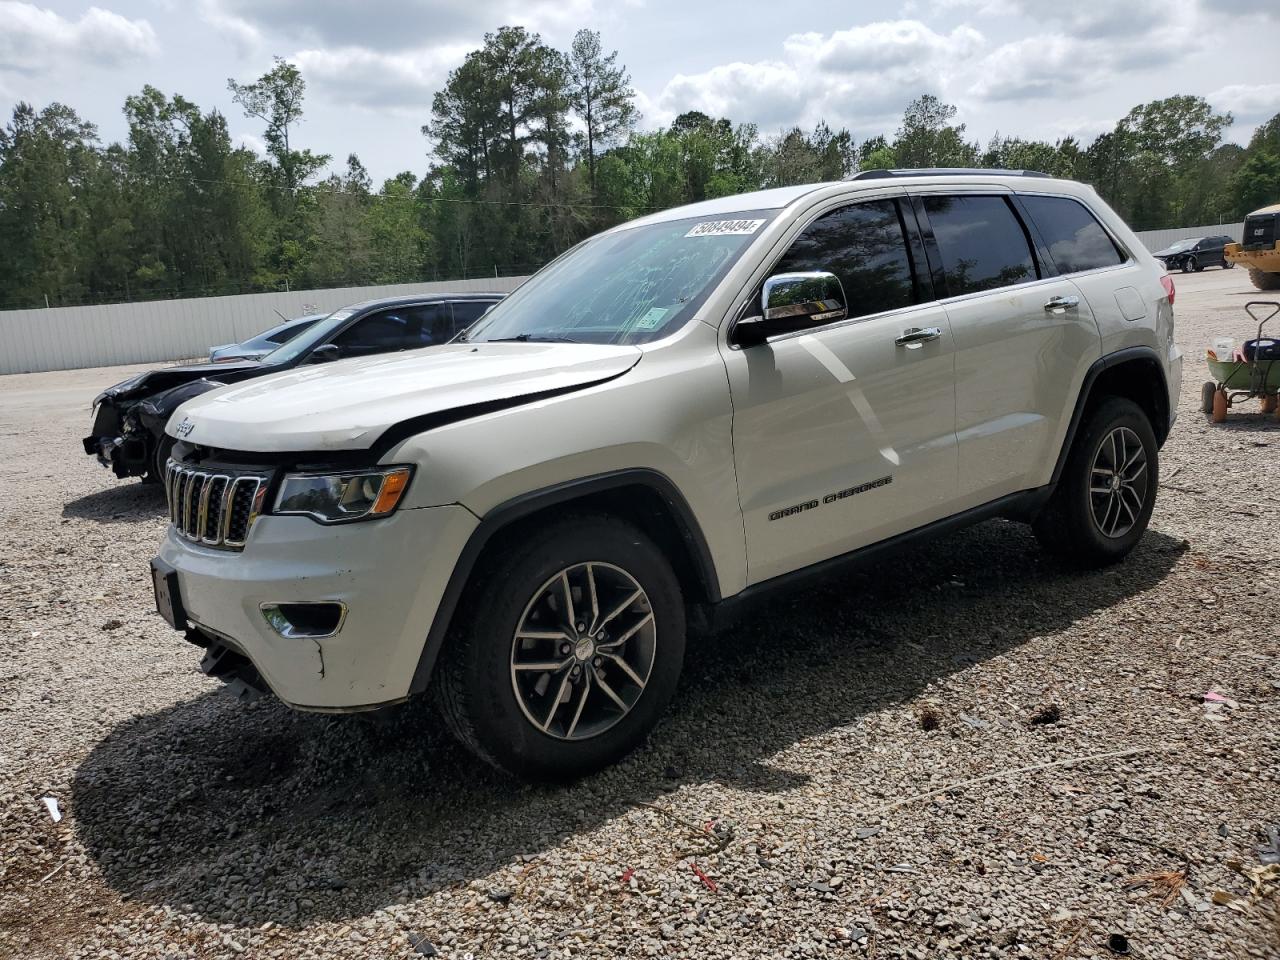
[0,0,159,74]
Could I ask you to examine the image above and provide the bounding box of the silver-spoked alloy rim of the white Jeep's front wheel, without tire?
[511,561,658,740]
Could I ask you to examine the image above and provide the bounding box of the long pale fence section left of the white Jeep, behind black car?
[0,276,525,374]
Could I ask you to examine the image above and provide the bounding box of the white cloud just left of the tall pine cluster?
[289,45,470,109]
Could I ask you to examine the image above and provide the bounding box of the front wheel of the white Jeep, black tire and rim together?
[435,515,685,781]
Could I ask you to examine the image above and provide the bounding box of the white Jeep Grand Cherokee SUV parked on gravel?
[154,170,1181,778]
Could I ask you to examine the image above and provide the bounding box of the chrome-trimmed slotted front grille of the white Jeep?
[165,460,269,550]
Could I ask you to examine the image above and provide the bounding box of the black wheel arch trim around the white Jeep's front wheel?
[410,467,721,694]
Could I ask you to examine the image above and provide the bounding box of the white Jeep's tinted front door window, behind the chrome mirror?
[773,200,919,317]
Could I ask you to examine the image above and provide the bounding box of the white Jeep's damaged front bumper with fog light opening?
[155,506,479,713]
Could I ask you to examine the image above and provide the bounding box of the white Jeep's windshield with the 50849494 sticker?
[458,210,774,344]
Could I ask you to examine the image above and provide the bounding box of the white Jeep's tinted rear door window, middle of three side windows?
[924,196,1038,297]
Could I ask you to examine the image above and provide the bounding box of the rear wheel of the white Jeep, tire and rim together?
[1032,397,1160,567]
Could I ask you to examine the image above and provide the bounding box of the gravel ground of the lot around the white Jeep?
[0,270,1280,960]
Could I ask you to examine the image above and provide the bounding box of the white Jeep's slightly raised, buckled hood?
[166,343,641,453]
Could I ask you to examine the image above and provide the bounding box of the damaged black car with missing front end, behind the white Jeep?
[82,293,504,483]
